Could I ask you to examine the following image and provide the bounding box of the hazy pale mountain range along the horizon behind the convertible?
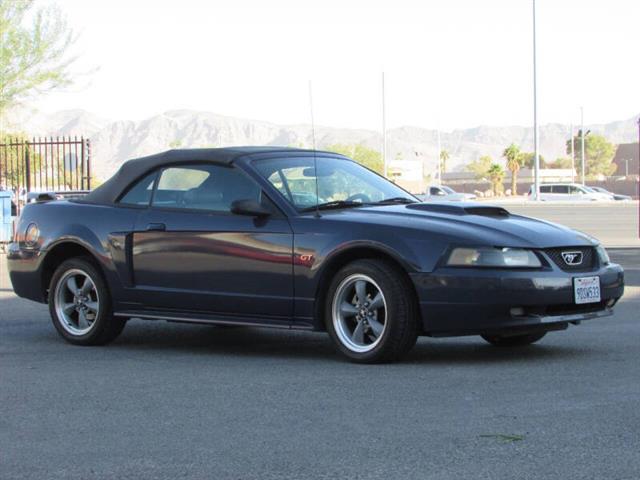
[11,110,638,179]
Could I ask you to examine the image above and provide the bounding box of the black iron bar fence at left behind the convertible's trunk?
[0,137,91,199]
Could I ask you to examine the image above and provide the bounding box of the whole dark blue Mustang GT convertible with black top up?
[9,147,624,362]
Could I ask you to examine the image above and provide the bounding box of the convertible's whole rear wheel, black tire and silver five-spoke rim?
[49,258,126,345]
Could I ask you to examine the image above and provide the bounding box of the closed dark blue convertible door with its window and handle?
[131,164,293,321]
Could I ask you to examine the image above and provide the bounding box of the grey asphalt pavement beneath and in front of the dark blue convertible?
[0,250,640,480]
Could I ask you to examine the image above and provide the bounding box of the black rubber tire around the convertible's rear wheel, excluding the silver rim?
[48,257,127,346]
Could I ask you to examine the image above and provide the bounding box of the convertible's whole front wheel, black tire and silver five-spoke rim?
[325,260,418,363]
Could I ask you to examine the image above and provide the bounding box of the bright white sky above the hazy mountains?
[34,0,640,130]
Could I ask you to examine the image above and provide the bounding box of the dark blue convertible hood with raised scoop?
[323,202,597,248]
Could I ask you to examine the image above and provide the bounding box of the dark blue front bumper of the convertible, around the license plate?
[411,264,624,336]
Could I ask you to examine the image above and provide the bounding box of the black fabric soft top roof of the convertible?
[82,147,340,203]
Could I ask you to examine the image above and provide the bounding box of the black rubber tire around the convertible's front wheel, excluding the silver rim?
[324,259,419,363]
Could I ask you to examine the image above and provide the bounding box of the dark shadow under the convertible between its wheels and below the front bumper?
[114,320,594,365]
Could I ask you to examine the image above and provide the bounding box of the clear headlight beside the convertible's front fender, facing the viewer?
[447,247,542,268]
